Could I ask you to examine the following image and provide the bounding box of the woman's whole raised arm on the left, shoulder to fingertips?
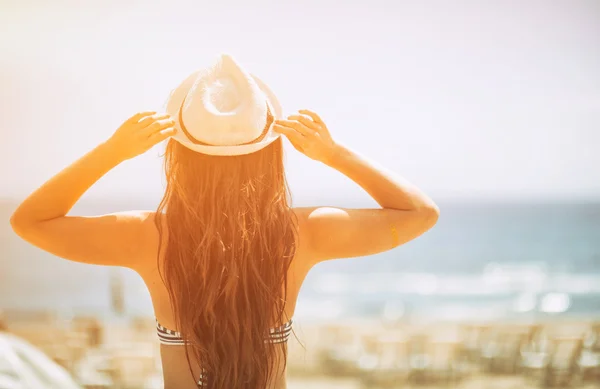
[10,112,174,266]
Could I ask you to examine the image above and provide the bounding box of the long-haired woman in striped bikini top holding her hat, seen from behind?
[11,55,438,389]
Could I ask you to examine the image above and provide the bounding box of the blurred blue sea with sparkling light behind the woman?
[0,201,600,321]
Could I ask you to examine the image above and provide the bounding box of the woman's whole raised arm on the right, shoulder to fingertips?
[275,110,439,265]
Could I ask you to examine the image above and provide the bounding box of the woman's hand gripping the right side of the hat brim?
[273,109,337,163]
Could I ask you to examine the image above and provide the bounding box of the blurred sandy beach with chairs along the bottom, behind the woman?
[5,313,600,389]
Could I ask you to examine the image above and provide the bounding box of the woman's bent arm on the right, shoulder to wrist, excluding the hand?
[298,141,439,263]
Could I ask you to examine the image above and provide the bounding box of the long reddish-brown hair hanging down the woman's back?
[156,131,298,389]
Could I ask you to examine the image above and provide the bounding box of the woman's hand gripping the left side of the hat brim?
[106,111,176,160]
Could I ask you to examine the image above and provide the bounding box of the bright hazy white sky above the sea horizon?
[0,0,600,204]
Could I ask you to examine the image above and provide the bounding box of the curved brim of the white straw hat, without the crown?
[167,74,283,155]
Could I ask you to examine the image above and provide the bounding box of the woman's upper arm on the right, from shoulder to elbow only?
[294,206,438,266]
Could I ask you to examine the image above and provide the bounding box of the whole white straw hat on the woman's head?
[167,54,282,155]
